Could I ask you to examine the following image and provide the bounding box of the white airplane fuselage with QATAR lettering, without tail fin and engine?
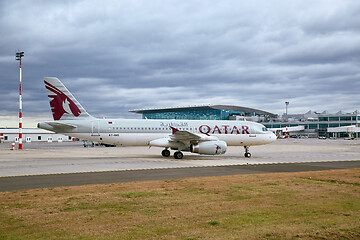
[39,118,276,146]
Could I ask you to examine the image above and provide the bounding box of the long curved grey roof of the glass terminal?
[129,105,276,116]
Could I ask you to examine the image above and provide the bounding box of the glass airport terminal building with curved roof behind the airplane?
[130,105,360,138]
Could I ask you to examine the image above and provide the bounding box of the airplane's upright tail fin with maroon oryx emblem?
[44,77,92,120]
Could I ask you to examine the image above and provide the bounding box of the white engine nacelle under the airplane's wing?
[190,141,227,155]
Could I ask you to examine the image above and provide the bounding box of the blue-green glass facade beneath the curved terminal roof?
[143,109,249,120]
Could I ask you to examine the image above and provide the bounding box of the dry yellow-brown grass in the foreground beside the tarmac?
[0,169,360,239]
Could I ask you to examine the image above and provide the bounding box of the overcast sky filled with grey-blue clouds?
[0,0,360,128]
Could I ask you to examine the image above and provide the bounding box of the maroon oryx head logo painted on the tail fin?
[45,81,81,120]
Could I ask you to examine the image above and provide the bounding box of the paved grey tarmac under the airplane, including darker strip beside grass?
[0,139,360,191]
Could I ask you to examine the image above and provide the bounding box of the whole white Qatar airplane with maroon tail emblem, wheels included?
[38,77,276,159]
